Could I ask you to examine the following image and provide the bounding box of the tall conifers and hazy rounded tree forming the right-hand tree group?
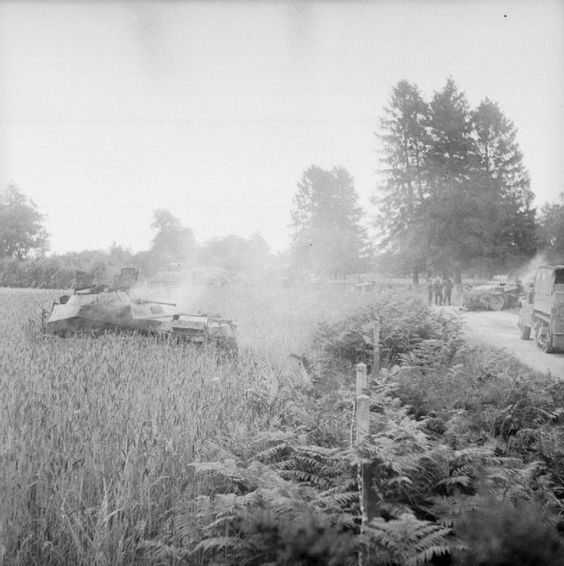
[292,78,564,282]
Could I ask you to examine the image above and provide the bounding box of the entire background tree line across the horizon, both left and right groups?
[0,78,564,286]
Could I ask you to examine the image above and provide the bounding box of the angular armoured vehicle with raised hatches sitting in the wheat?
[42,268,237,354]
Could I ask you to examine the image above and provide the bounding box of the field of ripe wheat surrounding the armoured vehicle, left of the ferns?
[0,287,388,564]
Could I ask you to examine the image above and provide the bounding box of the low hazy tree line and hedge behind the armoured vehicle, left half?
[0,192,271,289]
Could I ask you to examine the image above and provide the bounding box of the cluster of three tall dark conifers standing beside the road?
[373,78,535,280]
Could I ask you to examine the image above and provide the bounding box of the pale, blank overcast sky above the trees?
[0,0,564,252]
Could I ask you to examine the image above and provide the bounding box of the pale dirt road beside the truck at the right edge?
[454,307,564,379]
